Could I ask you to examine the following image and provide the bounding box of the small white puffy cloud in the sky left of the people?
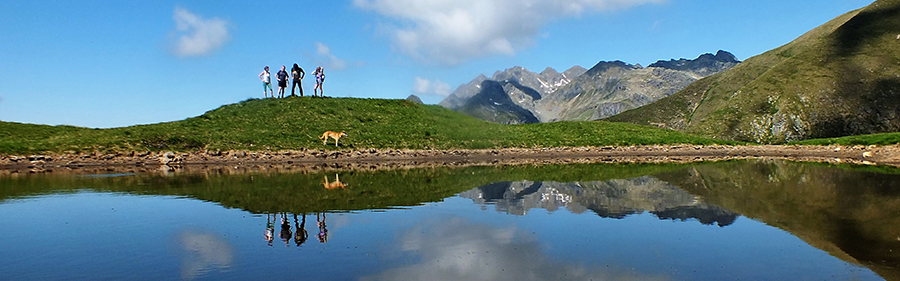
[173,7,231,57]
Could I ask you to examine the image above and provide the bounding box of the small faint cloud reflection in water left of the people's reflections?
[179,231,234,280]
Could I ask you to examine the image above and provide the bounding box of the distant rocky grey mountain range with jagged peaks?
[440,50,740,124]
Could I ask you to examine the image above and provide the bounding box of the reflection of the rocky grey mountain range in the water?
[460,176,740,226]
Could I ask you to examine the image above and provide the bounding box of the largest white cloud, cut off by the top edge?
[353,0,666,65]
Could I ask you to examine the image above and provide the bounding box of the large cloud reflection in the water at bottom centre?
[362,218,669,281]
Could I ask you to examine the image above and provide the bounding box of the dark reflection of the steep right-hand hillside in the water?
[654,161,900,280]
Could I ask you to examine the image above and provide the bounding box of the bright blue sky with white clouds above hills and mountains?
[0,0,872,128]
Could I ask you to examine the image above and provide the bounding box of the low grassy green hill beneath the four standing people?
[0,98,722,154]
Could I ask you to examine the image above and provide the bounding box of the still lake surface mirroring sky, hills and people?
[0,161,900,280]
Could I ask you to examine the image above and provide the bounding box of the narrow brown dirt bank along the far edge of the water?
[0,145,900,175]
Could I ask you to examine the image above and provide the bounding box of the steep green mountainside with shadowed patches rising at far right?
[608,0,900,143]
